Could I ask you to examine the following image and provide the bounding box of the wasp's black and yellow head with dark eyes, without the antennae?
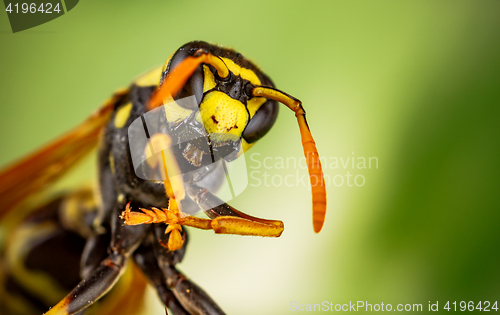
[156,41,279,166]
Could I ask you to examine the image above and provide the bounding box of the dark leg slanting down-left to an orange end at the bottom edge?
[46,204,148,315]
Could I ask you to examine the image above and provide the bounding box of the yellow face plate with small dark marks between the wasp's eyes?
[200,91,249,141]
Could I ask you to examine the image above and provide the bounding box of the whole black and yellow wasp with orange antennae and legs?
[0,41,326,315]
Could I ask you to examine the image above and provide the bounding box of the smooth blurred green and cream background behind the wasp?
[0,0,500,314]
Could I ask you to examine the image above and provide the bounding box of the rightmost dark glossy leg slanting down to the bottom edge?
[154,227,225,315]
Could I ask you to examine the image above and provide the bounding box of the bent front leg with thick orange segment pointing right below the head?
[186,183,284,237]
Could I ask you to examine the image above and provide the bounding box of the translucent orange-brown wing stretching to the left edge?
[0,90,127,219]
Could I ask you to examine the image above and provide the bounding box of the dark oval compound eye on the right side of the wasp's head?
[243,100,279,143]
